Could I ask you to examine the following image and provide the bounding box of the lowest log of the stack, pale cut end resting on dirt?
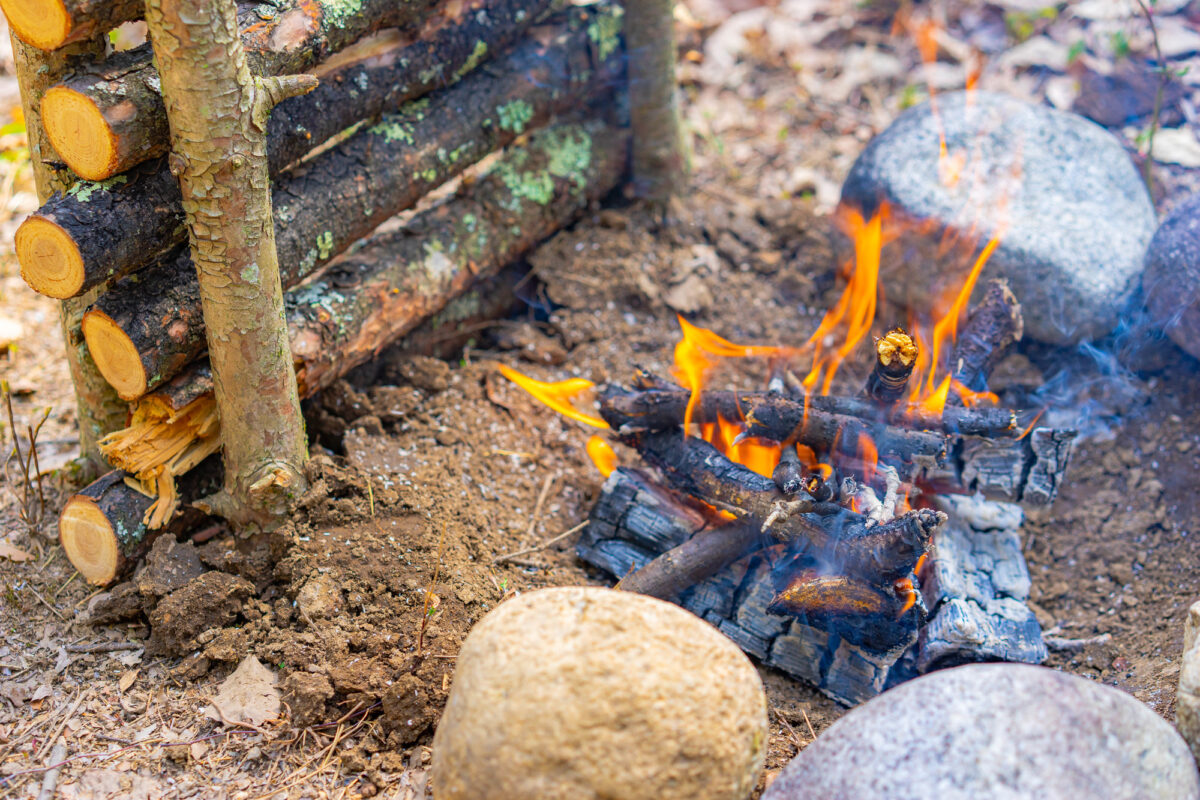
[59,456,221,587]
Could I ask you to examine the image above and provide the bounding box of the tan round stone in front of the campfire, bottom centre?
[433,587,767,800]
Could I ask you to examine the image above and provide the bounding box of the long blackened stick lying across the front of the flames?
[600,386,947,464]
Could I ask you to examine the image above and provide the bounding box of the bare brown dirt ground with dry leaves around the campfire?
[0,0,1200,800]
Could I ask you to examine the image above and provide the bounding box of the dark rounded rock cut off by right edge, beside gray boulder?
[1141,194,1200,359]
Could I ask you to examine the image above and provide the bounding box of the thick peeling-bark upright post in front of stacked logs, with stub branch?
[145,0,317,528]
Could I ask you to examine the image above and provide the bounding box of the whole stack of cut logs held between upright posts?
[2,0,629,584]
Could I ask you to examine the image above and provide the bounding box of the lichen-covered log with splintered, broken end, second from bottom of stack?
[90,115,628,510]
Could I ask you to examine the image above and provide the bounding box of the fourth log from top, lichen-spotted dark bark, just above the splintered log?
[84,23,619,399]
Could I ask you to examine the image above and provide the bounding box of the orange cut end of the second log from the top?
[42,86,117,181]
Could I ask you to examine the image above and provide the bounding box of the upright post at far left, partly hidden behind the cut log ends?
[11,35,128,474]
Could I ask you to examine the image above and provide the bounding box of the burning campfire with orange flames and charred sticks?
[499,206,1075,702]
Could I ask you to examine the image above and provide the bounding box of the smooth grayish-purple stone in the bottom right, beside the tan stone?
[762,663,1200,800]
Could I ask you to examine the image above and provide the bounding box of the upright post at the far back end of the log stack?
[625,0,688,204]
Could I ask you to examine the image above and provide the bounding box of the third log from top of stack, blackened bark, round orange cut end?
[16,0,561,299]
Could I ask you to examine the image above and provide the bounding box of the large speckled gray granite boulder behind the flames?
[842,91,1154,344]
